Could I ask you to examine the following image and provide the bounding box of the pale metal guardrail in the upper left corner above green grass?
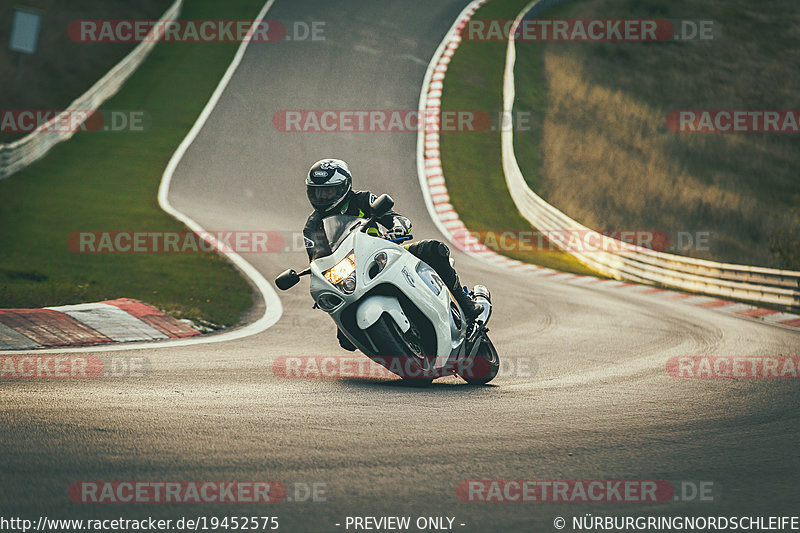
[0,0,183,179]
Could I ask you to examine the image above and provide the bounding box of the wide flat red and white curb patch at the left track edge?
[0,298,200,350]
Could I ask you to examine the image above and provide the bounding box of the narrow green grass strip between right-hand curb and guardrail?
[440,0,597,275]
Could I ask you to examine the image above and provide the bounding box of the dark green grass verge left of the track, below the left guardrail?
[0,0,263,325]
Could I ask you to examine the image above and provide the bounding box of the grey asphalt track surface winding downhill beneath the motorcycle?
[0,0,800,531]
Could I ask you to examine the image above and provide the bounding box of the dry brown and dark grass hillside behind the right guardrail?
[517,0,800,269]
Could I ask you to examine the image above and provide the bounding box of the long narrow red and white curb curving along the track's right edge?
[417,0,800,331]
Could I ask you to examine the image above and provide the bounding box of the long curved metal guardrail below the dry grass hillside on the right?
[501,0,800,310]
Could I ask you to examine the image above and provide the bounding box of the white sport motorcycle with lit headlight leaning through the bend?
[275,194,500,385]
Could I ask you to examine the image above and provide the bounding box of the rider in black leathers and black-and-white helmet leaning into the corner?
[303,159,483,350]
